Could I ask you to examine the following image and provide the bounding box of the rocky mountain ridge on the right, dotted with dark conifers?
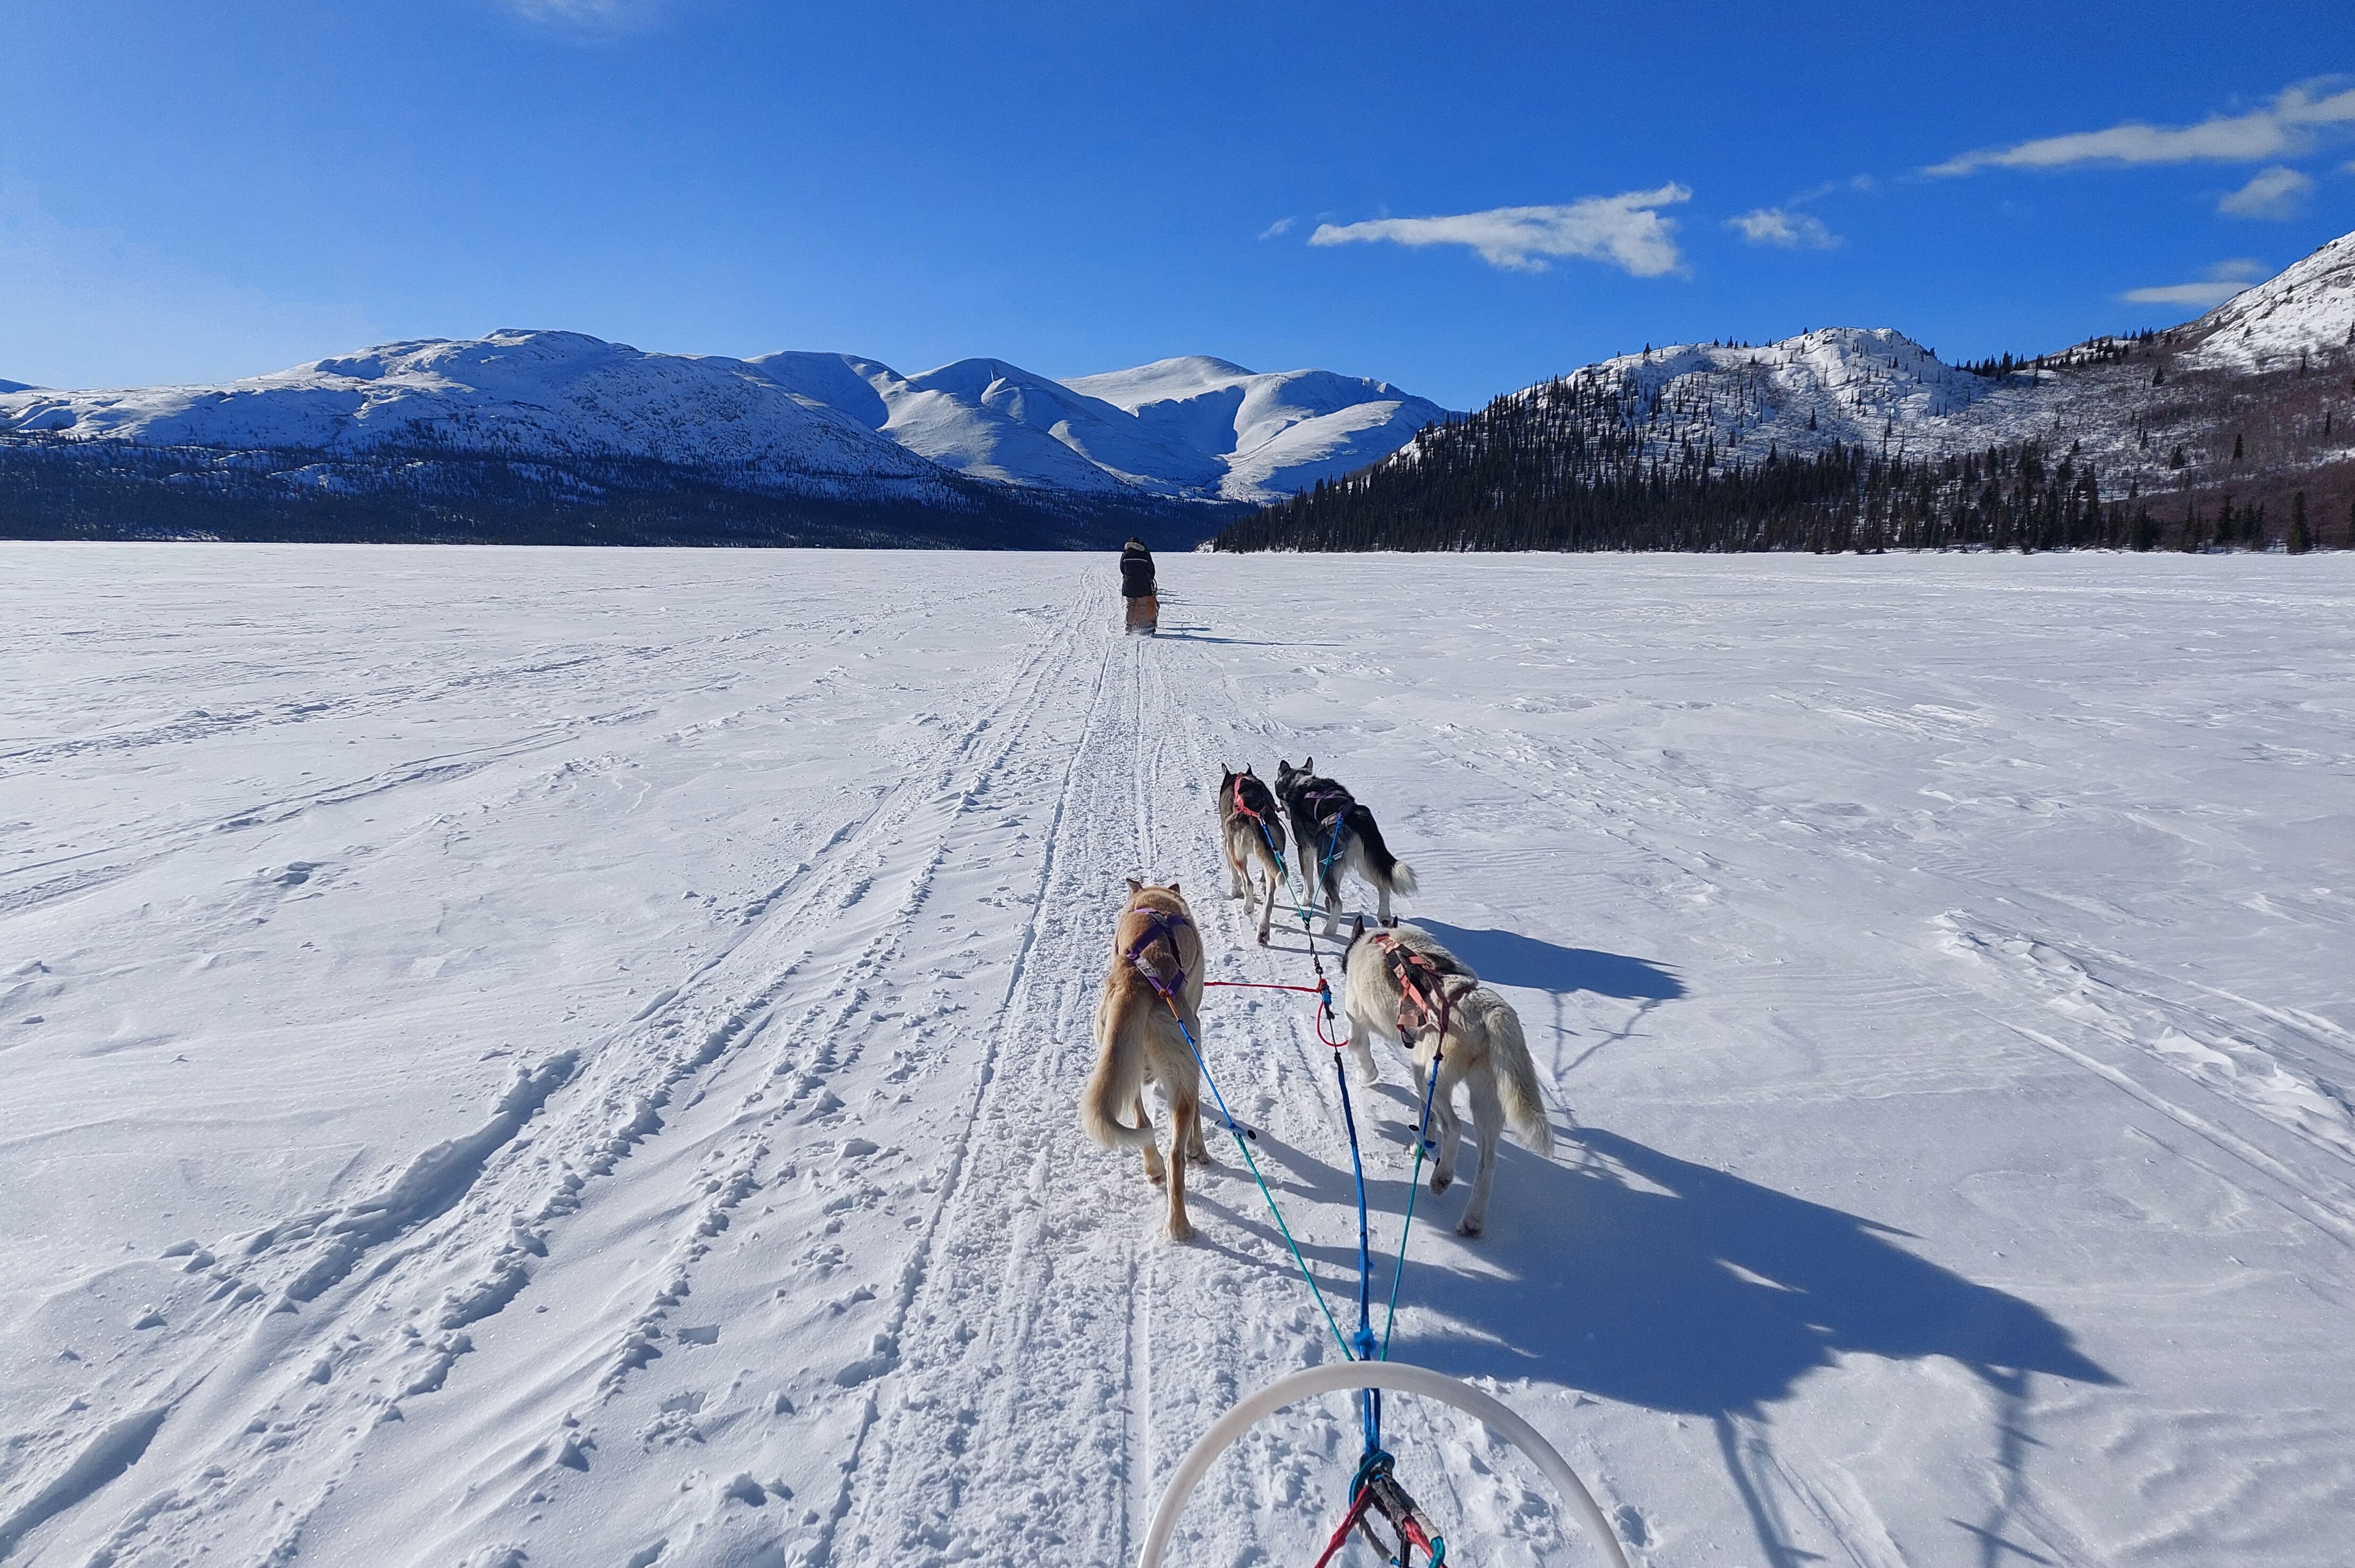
[1220,235,2355,549]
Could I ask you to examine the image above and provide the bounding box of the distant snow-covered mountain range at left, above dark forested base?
[0,330,1446,501]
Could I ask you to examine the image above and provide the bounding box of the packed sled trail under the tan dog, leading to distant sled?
[813,612,1469,1566]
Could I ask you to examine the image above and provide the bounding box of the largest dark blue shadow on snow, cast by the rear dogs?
[1234,1083,2117,1568]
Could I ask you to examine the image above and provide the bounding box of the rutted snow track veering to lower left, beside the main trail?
[2,577,1083,1568]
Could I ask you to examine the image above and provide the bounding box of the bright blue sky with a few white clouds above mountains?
[0,0,2355,407]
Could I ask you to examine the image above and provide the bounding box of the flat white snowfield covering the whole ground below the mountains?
[0,544,2355,1568]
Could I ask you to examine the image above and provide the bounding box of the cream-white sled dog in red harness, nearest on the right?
[1343,916,1554,1236]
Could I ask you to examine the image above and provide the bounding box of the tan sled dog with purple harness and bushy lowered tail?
[1078,878,1211,1241]
